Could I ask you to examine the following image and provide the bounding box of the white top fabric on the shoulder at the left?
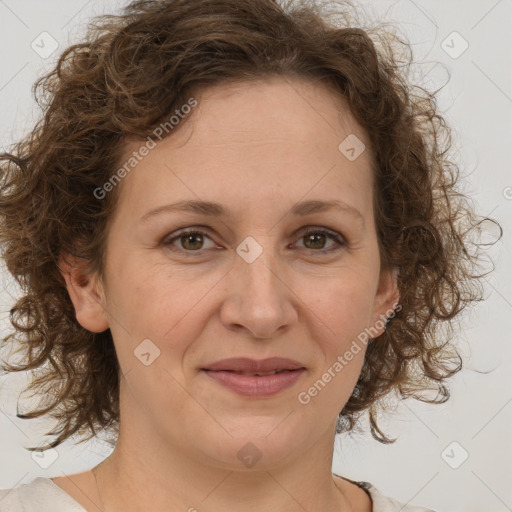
[0,477,85,512]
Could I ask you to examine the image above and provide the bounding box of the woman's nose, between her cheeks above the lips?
[220,244,298,339]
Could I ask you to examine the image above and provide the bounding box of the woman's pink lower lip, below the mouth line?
[203,368,306,397]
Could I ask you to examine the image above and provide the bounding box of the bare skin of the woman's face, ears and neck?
[54,77,399,512]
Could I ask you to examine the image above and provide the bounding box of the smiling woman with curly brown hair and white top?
[0,0,496,512]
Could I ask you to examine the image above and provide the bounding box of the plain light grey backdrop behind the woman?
[0,0,512,512]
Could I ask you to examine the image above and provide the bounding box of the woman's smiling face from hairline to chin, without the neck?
[65,78,398,468]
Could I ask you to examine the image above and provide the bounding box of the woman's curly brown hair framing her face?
[0,0,501,449]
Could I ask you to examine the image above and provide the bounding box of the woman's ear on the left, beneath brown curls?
[59,253,109,332]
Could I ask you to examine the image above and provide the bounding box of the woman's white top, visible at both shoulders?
[0,477,434,512]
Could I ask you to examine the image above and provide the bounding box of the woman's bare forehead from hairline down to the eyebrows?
[114,77,372,218]
